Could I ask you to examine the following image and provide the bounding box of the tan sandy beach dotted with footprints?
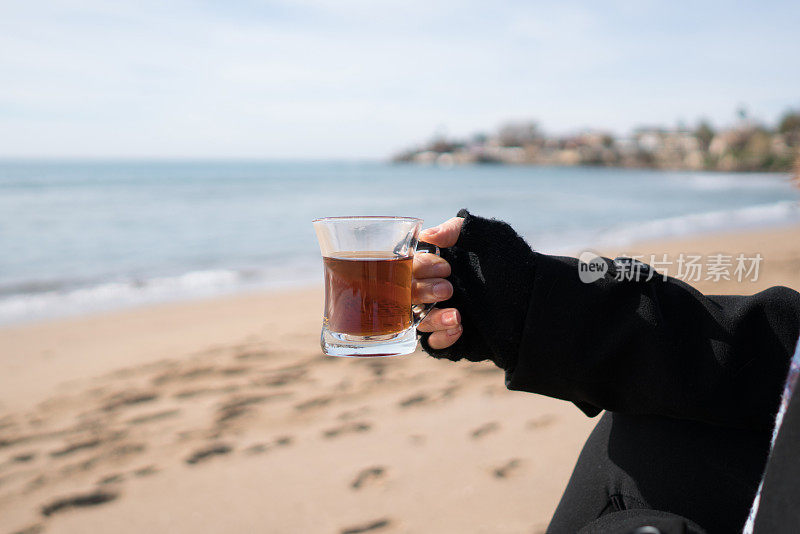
[0,227,800,534]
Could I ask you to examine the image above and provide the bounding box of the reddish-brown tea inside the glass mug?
[323,251,413,336]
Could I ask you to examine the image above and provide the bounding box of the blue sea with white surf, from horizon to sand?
[0,161,800,324]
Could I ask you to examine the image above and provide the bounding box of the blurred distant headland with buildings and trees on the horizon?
[392,111,800,177]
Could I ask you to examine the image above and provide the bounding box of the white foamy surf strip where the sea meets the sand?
[0,200,800,330]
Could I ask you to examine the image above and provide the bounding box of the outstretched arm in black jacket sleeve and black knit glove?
[422,210,800,428]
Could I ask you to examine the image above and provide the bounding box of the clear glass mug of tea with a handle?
[312,216,439,357]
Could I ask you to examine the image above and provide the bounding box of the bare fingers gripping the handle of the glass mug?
[411,217,464,349]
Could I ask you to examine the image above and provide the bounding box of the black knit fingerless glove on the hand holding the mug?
[421,209,534,370]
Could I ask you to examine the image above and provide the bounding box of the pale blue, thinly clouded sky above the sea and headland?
[0,0,800,159]
